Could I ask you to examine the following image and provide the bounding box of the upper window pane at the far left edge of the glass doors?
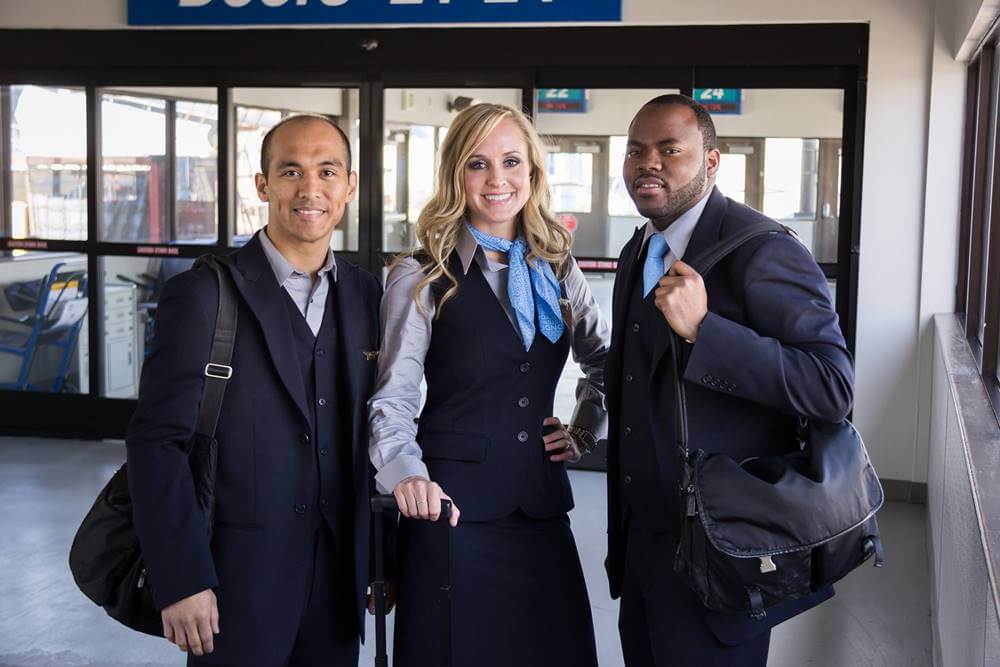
[10,86,87,240]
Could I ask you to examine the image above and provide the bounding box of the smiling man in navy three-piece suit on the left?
[127,116,381,667]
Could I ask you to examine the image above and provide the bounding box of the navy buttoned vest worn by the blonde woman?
[417,253,573,521]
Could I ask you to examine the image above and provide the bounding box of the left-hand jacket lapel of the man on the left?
[233,232,312,425]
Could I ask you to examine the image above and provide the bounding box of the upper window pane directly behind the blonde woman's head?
[382,88,521,252]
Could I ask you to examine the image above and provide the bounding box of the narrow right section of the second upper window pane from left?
[173,101,219,243]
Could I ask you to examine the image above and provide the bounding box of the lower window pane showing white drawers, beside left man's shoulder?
[100,257,194,398]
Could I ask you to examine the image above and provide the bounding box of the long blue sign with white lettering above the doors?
[128,0,622,25]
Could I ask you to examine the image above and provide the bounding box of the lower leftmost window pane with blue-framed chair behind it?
[0,251,90,393]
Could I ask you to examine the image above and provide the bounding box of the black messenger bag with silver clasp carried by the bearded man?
[671,223,883,620]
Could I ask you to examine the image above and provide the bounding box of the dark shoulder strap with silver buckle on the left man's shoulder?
[195,255,238,438]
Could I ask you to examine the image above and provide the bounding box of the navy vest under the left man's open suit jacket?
[281,280,353,539]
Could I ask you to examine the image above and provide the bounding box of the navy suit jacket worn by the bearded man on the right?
[605,189,854,644]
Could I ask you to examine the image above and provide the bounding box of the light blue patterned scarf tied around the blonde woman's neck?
[465,223,563,350]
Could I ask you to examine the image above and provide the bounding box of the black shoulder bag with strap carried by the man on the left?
[69,255,237,637]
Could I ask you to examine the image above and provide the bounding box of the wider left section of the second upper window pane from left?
[101,94,171,243]
